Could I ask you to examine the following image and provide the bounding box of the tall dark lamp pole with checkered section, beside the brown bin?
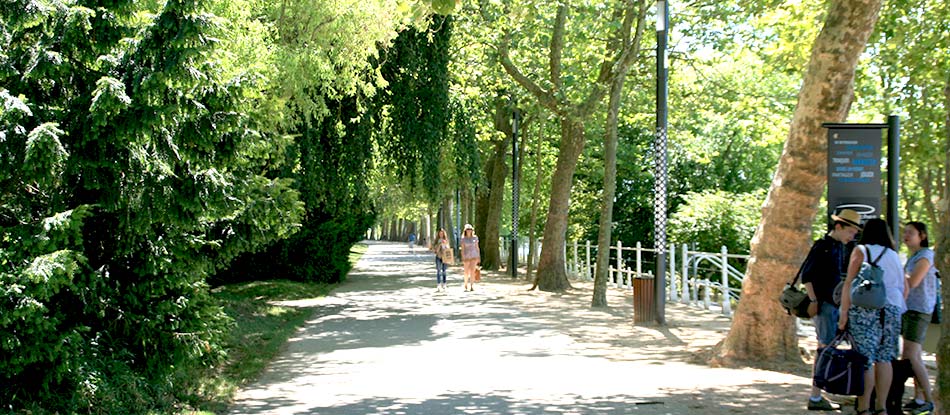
[653,0,670,324]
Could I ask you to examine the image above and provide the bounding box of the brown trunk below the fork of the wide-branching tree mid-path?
[536,117,584,292]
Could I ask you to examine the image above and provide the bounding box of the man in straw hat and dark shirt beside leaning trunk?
[801,209,861,411]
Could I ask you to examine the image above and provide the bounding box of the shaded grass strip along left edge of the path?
[183,244,367,415]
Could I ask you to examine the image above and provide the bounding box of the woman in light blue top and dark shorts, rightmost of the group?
[901,222,937,414]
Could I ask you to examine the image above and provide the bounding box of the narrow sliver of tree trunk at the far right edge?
[934,70,950,414]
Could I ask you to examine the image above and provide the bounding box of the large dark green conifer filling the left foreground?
[0,1,303,413]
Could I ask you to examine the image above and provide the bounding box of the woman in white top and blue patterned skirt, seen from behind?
[838,218,907,415]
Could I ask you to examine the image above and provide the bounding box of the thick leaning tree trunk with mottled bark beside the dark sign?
[713,0,881,365]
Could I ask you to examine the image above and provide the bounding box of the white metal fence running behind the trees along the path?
[501,240,749,316]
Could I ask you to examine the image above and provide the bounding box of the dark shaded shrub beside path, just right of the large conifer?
[227,97,376,283]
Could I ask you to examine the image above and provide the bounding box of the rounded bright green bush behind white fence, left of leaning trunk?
[669,190,765,254]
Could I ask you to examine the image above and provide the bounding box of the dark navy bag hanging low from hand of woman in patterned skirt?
[812,330,868,396]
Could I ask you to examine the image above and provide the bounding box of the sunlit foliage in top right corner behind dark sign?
[852,0,950,232]
